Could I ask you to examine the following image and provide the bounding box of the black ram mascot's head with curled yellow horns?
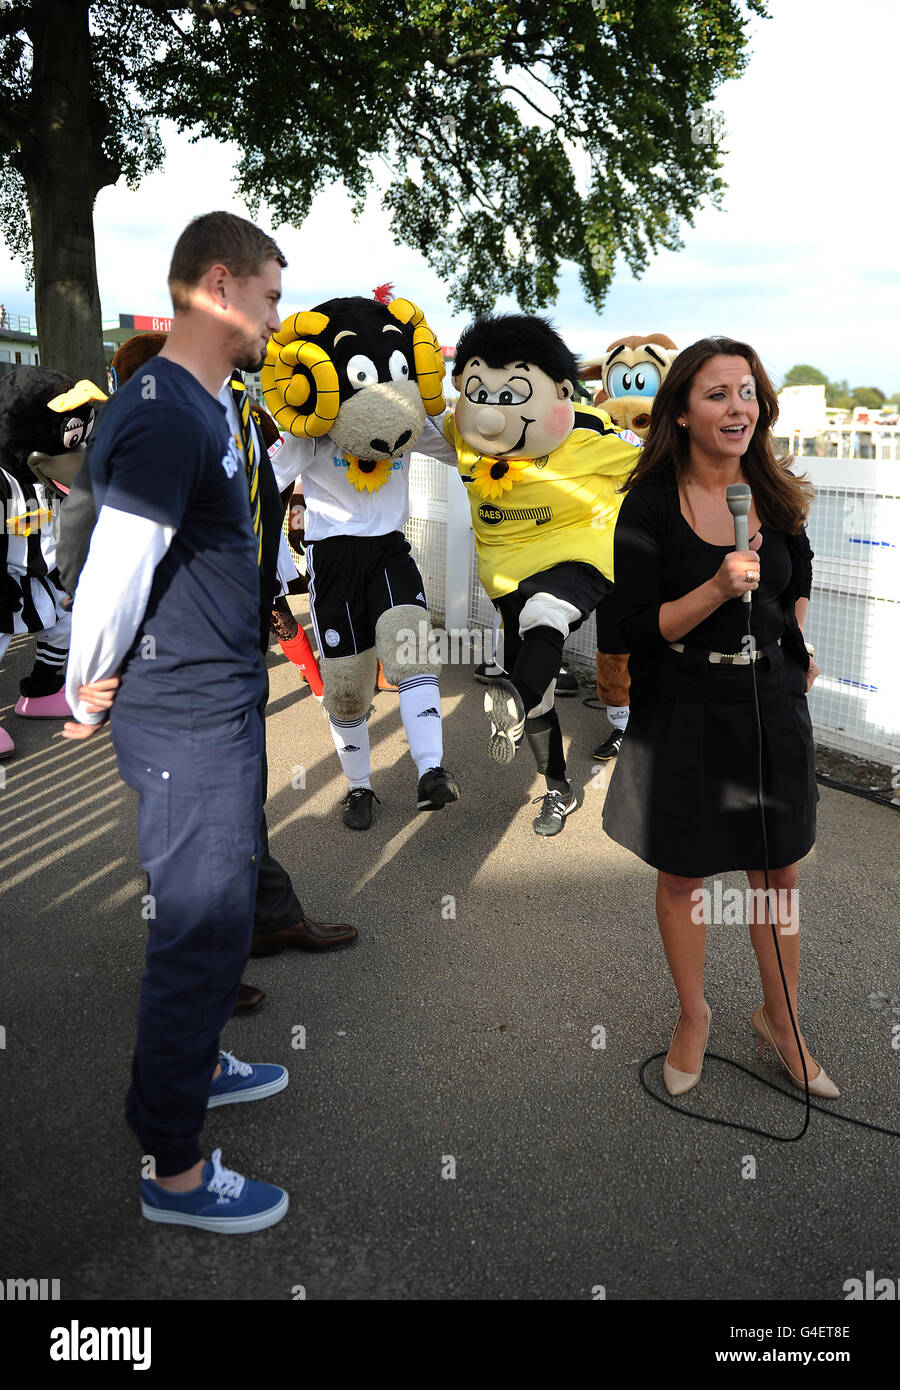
[262,296,447,459]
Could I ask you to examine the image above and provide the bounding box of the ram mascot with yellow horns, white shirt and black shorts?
[262,296,459,830]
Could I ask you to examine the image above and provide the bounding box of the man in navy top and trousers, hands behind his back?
[64,213,296,1233]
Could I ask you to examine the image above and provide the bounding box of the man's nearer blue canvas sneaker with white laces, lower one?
[140,1148,288,1236]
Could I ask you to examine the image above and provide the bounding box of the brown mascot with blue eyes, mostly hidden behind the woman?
[581,334,677,762]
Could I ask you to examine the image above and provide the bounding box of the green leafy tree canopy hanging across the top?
[0,0,766,378]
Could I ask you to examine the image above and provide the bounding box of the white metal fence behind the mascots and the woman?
[406,455,900,765]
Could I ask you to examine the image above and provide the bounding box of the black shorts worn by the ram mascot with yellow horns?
[306,531,428,656]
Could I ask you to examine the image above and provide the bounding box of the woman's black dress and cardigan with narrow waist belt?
[602,475,818,878]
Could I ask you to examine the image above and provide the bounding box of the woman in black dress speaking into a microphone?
[604,338,839,1095]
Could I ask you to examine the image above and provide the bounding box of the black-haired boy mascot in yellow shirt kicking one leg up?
[442,314,637,835]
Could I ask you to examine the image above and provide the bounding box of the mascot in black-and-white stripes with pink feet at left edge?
[0,367,106,758]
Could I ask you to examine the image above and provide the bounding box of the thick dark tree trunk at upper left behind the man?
[21,0,118,389]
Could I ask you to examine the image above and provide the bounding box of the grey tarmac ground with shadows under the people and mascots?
[0,599,900,1312]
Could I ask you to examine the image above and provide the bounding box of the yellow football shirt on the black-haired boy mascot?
[442,406,640,599]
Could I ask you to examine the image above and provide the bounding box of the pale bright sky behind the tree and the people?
[0,0,900,393]
